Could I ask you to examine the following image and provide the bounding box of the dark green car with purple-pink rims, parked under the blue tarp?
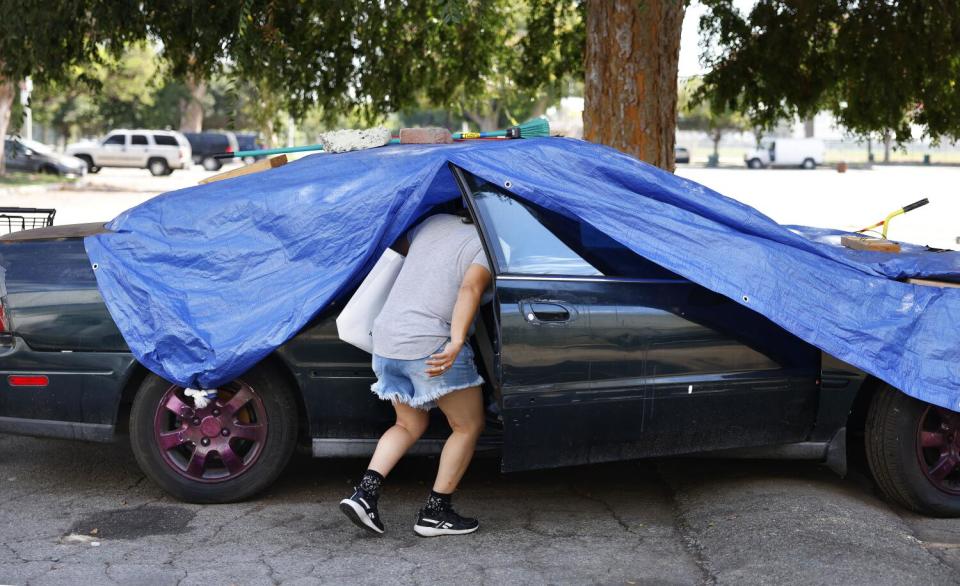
[0,176,960,516]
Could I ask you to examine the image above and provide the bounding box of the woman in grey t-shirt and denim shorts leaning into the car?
[340,214,490,537]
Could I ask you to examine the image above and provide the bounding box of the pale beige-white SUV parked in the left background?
[67,129,191,176]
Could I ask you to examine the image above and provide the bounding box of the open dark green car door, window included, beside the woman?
[453,167,820,471]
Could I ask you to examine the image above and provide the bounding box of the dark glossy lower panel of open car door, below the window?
[497,277,819,470]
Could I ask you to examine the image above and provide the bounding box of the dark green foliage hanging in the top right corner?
[699,0,960,142]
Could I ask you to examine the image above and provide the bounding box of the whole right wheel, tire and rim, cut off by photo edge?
[865,384,960,517]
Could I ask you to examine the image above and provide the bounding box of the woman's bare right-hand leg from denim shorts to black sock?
[433,387,485,494]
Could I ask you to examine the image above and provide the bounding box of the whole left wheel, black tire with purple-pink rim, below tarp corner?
[130,364,299,503]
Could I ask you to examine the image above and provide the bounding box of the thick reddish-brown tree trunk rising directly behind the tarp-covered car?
[583,0,685,171]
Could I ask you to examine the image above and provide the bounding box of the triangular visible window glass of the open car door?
[468,171,681,280]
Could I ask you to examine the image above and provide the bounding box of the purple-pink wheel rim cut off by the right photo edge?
[917,405,960,495]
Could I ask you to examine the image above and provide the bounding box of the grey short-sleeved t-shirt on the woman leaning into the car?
[373,214,490,360]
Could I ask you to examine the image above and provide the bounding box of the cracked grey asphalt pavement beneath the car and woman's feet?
[0,435,960,585]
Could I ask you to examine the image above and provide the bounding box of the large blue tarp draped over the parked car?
[86,138,960,410]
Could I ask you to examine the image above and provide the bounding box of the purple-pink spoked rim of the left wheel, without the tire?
[153,380,267,484]
